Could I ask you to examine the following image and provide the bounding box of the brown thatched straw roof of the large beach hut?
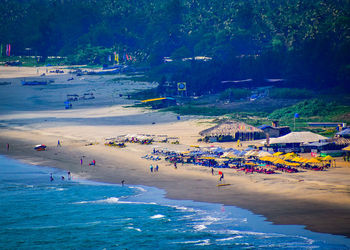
[199,121,264,136]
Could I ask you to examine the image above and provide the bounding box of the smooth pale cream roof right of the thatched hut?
[262,131,328,144]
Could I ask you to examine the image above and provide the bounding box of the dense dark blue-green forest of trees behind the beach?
[0,0,350,93]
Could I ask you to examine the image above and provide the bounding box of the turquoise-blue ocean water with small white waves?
[0,156,350,249]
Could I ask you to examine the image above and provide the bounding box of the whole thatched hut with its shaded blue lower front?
[199,121,265,142]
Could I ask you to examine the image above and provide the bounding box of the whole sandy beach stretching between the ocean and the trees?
[0,67,350,237]
